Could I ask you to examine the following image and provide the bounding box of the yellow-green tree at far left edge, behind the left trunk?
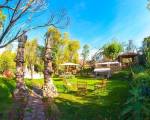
[0,50,16,72]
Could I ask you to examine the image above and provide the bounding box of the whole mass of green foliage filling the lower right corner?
[121,68,150,120]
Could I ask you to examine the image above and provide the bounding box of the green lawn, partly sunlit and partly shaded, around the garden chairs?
[0,72,128,120]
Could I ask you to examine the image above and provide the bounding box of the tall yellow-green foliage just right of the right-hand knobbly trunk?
[47,27,80,72]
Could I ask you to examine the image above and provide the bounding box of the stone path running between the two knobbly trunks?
[23,91,46,120]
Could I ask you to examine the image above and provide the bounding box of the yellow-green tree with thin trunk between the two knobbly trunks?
[25,40,38,79]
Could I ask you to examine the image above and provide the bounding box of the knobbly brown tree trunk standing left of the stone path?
[14,35,27,100]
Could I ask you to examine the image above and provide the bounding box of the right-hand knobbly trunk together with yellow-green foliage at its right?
[43,27,80,98]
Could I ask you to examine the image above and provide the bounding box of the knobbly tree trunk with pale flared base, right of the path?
[43,33,58,98]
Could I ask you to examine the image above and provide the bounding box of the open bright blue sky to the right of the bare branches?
[30,0,150,49]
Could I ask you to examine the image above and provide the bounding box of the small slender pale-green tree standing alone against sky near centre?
[82,44,90,68]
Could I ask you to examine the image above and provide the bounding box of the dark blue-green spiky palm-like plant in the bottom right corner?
[121,87,149,120]
